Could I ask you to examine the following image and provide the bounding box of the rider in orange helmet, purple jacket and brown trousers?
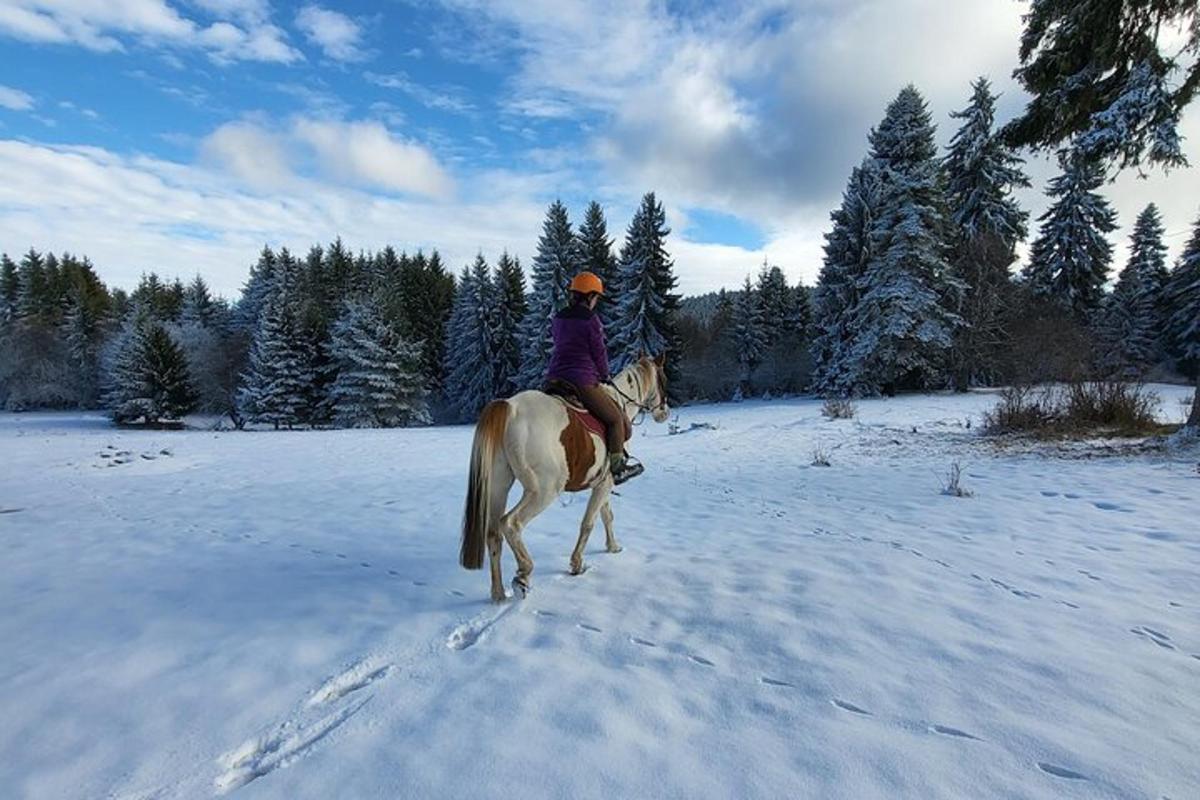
[546,272,642,483]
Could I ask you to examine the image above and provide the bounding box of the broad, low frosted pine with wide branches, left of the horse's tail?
[330,293,430,428]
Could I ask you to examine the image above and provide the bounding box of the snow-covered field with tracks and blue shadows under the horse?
[0,387,1200,800]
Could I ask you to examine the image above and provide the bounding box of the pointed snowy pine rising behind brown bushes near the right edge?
[1098,203,1168,379]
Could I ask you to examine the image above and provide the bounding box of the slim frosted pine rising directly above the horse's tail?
[445,254,499,421]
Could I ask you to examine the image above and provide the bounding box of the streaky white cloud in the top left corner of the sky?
[0,0,304,64]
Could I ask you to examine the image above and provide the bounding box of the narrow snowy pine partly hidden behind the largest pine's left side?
[809,158,882,397]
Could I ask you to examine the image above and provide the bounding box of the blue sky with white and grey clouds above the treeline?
[0,0,1200,297]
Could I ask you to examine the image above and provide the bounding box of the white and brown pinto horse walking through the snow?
[458,356,671,602]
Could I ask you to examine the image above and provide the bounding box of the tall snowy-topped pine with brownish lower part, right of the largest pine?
[942,78,1030,391]
